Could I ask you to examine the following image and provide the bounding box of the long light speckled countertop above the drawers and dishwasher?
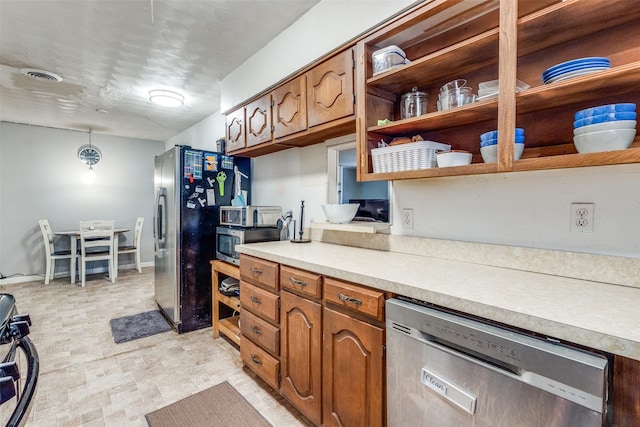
[238,241,640,361]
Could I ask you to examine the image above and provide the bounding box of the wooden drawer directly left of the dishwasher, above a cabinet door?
[324,278,384,321]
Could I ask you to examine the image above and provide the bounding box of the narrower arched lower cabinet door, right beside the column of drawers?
[280,292,322,425]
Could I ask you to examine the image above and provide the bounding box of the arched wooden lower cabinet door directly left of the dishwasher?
[322,308,385,427]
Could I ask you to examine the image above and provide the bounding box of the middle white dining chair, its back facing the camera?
[80,220,115,287]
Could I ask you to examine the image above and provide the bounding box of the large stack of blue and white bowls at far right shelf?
[573,103,636,154]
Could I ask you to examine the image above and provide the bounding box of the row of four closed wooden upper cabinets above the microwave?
[227,48,356,156]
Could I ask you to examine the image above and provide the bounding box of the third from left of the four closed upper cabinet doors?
[272,75,307,138]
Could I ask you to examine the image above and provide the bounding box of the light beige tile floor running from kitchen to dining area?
[0,267,306,427]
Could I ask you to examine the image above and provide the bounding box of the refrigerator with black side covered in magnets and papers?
[153,146,250,333]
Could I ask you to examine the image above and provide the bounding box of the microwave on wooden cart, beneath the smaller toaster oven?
[216,227,280,265]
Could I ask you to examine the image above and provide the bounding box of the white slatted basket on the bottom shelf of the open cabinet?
[371,141,451,173]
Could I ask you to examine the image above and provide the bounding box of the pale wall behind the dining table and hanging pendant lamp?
[0,122,165,276]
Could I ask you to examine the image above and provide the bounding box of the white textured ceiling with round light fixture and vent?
[0,0,319,141]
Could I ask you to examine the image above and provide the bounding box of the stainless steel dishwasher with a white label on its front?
[386,298,608,427]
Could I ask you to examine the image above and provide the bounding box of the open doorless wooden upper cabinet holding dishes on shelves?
[356,0,640,181]
